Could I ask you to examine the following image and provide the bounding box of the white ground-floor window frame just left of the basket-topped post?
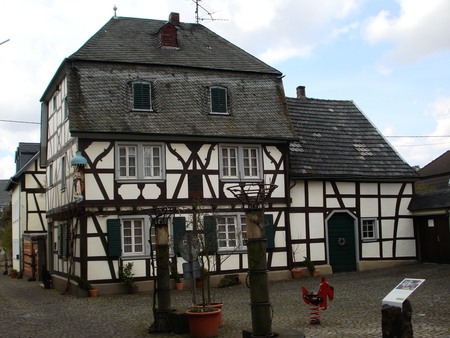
[215,213,247,253]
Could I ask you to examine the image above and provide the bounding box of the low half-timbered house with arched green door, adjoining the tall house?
[287,86,418,272]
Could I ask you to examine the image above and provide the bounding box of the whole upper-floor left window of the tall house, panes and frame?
[116,143,164,180]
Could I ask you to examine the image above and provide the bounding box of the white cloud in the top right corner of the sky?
[365,0,450,64]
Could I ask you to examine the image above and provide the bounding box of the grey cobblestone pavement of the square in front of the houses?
[0,264,450,338]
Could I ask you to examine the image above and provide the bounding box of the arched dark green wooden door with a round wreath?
[328,212,356,272]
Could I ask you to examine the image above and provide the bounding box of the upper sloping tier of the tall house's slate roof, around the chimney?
[69,17,281,75]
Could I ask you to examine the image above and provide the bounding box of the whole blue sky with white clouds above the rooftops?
[0,0,450,179]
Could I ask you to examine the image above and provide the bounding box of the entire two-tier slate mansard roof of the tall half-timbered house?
[41,17,296,142]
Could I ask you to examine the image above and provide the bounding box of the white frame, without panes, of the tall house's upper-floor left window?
[115,142,166,182]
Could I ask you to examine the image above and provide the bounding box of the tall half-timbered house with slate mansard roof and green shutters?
[41,13,296,293]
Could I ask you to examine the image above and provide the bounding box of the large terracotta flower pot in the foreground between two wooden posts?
[186,308,222,338]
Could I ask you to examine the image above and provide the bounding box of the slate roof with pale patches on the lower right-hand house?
[287,98,418,180]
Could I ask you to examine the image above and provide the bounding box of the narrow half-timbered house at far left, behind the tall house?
[6,142,47,279]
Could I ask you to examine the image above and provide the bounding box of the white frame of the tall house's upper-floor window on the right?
[219,144,264,182]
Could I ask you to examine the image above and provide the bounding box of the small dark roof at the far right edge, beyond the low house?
[418,150,450,190]
